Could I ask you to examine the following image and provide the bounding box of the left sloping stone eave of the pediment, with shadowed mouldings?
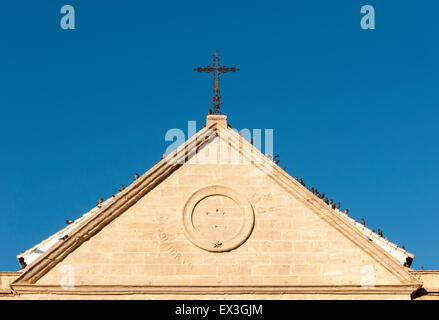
[15,119,218,283]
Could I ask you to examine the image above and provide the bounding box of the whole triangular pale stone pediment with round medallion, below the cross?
[14,116,419,293]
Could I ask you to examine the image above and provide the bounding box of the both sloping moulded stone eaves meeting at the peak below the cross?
[14,115,420,286]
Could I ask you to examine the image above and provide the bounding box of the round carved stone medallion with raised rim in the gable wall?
[183,186,255,252]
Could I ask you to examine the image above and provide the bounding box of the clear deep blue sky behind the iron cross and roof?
[0,0,439,271]
